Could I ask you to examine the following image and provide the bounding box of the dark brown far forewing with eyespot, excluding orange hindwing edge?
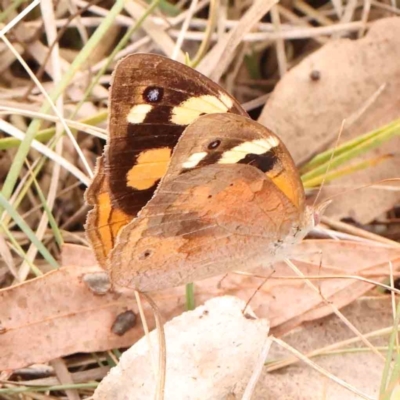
[105,54,246,216]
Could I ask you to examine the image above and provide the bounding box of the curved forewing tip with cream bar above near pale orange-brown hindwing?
[158,113,305,210]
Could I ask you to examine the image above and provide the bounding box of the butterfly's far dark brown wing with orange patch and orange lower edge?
[86,54,247,266]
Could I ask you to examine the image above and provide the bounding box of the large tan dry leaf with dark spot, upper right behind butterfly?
[259,18,400,222]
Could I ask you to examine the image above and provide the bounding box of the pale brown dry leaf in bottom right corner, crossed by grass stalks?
[254,297,393,400]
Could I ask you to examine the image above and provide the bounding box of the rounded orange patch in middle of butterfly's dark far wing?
[126,147,171,190]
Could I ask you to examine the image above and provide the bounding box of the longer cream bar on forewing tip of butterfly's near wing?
[218,136,279,164]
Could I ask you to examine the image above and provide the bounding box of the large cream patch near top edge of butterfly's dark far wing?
[171,94,232,125]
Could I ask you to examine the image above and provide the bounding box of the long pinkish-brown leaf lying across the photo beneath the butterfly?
[0,240,400,370]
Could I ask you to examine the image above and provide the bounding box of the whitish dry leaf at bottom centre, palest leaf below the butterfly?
[93,296,269,400]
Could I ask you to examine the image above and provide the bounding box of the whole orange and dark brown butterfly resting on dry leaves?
[85,54,319,292]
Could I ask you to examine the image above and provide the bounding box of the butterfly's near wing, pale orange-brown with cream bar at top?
[109,114,312,291]
